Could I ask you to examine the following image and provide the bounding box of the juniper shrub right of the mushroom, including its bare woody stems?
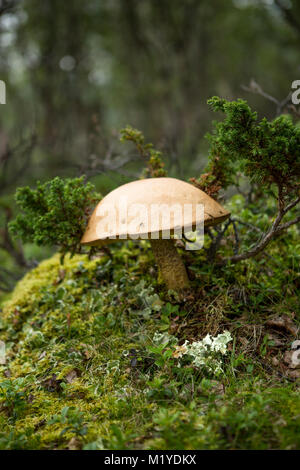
[191,96,300,263]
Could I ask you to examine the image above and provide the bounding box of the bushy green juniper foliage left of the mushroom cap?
[9,176,100,255]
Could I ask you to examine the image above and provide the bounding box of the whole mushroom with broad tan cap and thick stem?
[81,178,230,291]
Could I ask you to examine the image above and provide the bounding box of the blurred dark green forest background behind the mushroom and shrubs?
[0,0,300,294]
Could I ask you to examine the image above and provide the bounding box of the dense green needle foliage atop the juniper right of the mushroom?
[198,96,300,197]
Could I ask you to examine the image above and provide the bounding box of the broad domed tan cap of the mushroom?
[81,178,230,245]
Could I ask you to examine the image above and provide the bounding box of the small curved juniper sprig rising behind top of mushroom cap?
[121,126,167,178]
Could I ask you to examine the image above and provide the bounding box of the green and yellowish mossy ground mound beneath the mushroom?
[0,226,300,449]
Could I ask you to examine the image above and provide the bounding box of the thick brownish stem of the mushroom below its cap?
[150,239,189,291]
